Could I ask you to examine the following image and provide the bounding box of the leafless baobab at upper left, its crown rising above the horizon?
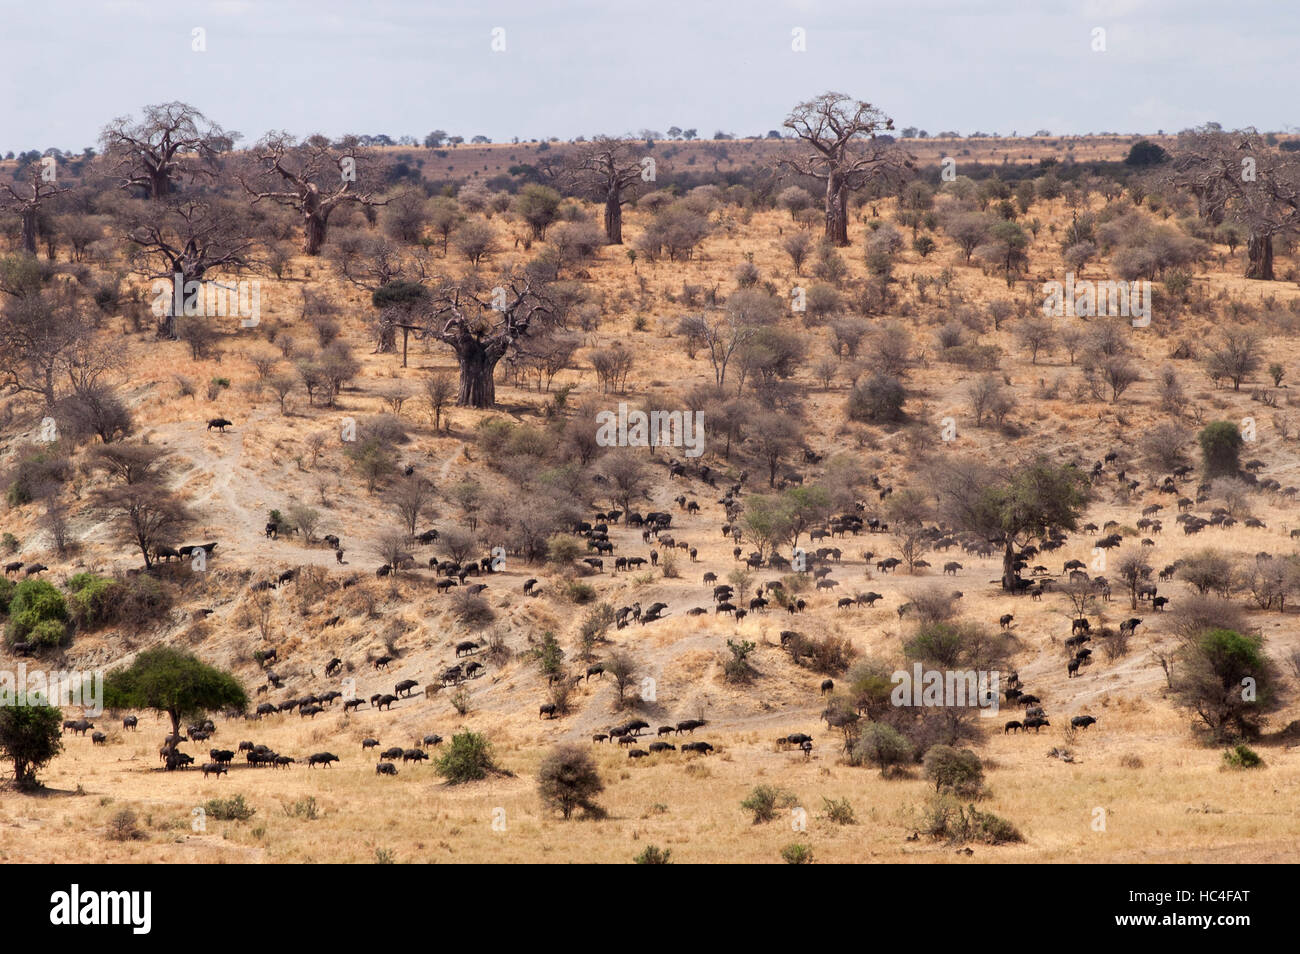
[99,101,242,200]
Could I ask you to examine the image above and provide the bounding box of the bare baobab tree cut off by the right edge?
[1164,126,1300,281]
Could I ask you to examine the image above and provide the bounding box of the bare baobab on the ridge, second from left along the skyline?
[239,131,387,255]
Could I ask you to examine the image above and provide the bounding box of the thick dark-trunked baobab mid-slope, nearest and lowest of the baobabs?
[421,273,555,408]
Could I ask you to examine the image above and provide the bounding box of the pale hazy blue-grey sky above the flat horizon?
[0,0,1300,151]
